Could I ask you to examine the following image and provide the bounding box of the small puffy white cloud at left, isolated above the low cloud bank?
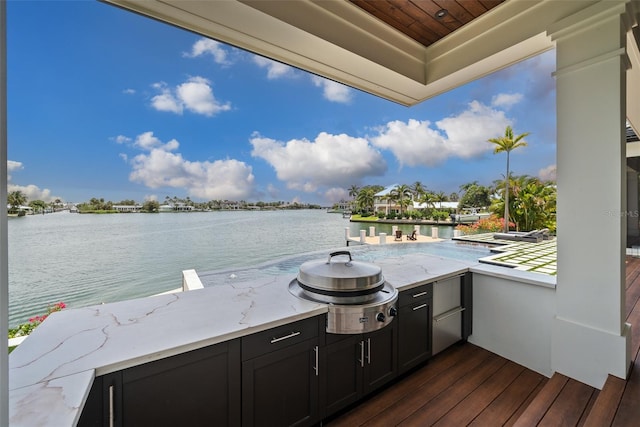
[151,76,231,117]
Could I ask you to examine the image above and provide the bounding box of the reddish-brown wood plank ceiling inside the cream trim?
[349,0,504,46]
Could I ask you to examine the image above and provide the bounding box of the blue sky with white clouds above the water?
[7,1,556,205]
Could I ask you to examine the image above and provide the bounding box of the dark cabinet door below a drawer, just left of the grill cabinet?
[241,338,319,427]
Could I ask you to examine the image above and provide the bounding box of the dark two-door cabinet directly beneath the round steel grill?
[320,322,398,416]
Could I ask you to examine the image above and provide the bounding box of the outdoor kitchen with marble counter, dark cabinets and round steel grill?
[10,244,554,425]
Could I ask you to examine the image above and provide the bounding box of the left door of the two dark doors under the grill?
[320,334,365,416]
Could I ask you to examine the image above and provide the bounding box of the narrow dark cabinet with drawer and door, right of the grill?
[398,283,433,374]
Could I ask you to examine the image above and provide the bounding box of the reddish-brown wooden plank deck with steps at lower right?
[325,257,640,427]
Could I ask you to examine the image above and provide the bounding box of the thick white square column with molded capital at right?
[548,2,630,388]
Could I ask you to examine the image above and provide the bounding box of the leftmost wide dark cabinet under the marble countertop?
[78,340,240,426]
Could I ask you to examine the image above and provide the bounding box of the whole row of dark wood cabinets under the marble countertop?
[78,274,472,427]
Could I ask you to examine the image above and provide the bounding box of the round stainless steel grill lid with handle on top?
[298,251,384,294]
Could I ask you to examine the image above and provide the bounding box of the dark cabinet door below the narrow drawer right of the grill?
[398,300,432,374]
